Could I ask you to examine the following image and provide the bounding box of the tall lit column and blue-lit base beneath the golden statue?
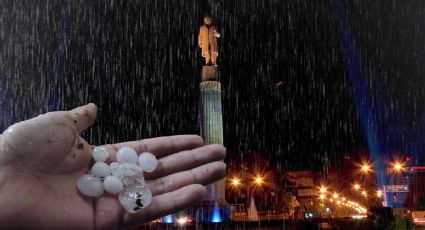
[196,66,231,224]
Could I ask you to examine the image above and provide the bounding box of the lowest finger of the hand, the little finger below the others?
[123,184,206,227]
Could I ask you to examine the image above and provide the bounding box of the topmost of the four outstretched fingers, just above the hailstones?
[104,135,204,161]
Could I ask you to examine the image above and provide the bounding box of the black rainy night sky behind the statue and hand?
[0,0,425,169]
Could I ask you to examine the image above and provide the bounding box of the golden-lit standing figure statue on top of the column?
[198,16,220,66]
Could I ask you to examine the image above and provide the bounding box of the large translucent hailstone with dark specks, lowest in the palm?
[119,184,152,213]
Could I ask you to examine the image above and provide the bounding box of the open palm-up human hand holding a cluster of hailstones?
[0,104,225,229]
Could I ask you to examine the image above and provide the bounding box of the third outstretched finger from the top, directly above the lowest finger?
[146,161,226,196]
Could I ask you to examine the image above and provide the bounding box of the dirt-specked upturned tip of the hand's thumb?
[67,103,97,133]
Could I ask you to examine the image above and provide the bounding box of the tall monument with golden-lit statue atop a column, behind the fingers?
[196,16,230,223]
